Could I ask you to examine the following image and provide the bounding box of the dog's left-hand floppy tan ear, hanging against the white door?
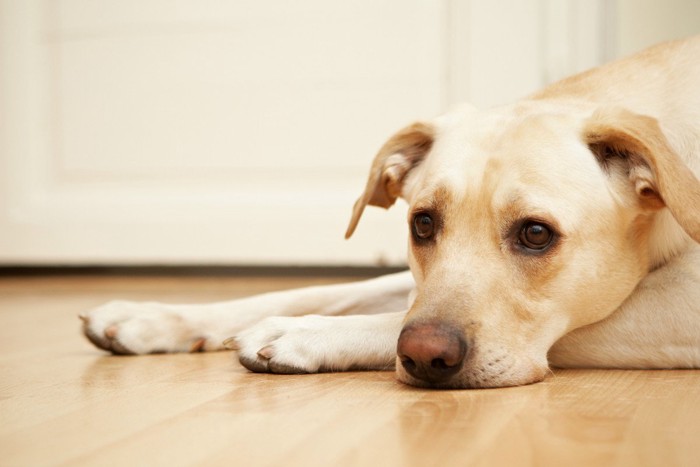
[345,122,435,238]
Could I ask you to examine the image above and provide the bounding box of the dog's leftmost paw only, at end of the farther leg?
[80,301,211,355]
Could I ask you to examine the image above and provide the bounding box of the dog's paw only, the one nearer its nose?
[224,315,335,374]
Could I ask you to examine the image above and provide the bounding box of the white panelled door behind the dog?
[0,0,602,265]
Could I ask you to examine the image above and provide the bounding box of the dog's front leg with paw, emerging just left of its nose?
[227,311,406,374]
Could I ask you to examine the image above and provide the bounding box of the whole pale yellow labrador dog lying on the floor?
[81,38,700,388]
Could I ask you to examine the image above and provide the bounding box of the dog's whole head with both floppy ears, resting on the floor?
[347,103,700,388]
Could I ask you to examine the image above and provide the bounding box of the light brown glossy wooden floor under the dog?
[0,277,700,467]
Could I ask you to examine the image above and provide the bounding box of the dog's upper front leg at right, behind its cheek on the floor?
[549,246,700,369]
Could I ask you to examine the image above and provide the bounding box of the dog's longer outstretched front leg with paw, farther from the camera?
[81,272,413,354]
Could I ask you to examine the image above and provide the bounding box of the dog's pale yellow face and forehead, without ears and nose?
[398,108,646,387]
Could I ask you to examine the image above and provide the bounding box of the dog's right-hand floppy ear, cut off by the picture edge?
[584,109,700,242]
